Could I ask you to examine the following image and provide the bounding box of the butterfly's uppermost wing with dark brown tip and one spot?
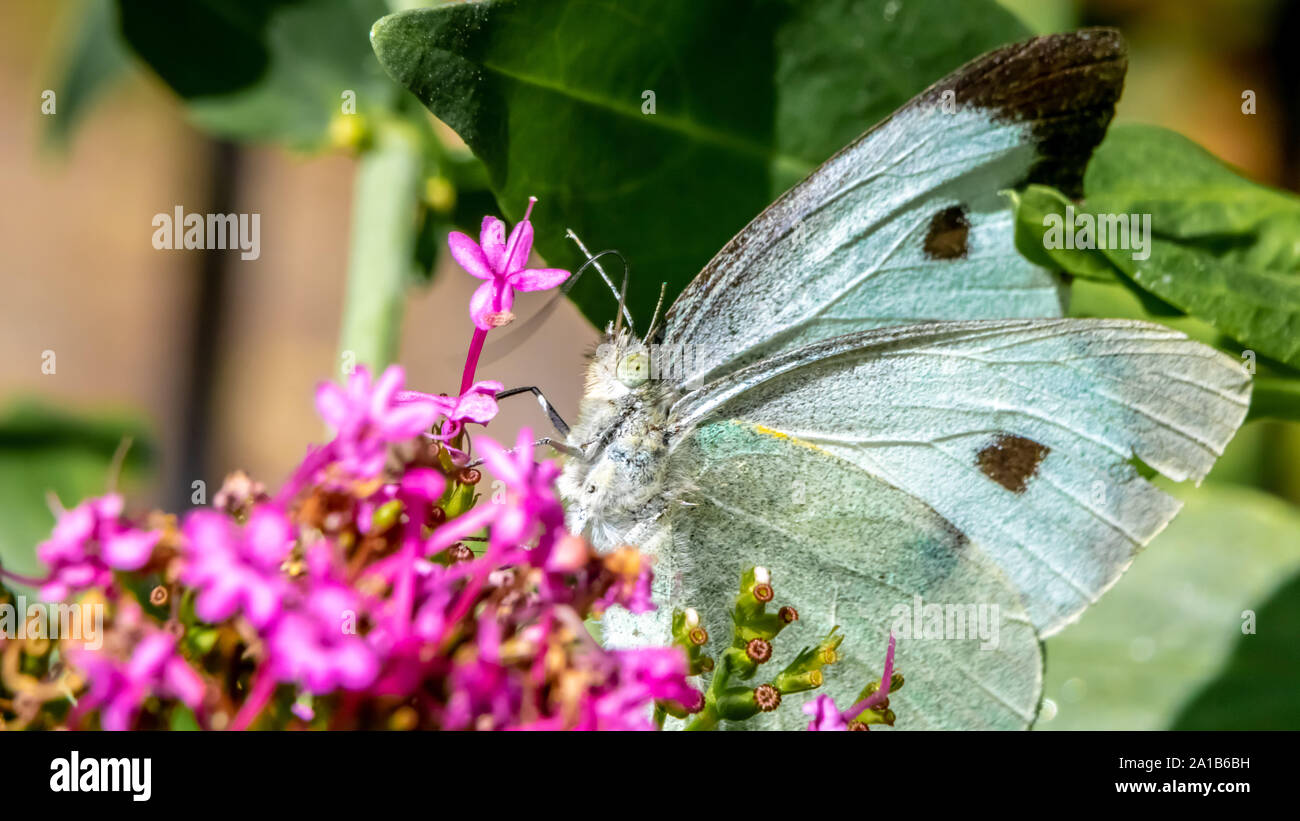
[664,29,1126,385]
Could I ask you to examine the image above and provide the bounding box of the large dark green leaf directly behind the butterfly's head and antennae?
[371,0,1027,323]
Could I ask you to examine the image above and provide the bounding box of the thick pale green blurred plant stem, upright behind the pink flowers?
[339,121,423,372]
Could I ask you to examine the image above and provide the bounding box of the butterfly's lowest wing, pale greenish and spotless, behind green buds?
[657,421,1043,729]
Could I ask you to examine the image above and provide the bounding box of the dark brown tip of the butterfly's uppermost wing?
[923,29,1128,196]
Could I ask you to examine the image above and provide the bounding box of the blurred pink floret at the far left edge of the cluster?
[36,494,163,601]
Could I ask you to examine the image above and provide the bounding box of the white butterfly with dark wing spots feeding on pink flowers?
[560,30,1251,727]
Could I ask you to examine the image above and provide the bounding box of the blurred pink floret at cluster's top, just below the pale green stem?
[316,365,438,478]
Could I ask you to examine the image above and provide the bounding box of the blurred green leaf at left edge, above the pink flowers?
[0,401,153,597]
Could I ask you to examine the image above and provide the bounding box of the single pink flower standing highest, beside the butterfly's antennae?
[447,207,569,331]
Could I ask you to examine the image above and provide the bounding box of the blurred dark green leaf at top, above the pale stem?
[117,0,400,148]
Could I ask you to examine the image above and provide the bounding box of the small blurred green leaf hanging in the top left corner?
[43,0,131,148]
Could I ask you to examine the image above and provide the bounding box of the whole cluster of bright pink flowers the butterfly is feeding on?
[7,203,702,729]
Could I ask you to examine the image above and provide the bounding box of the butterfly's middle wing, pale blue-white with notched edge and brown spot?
[671,320,1249,635]
